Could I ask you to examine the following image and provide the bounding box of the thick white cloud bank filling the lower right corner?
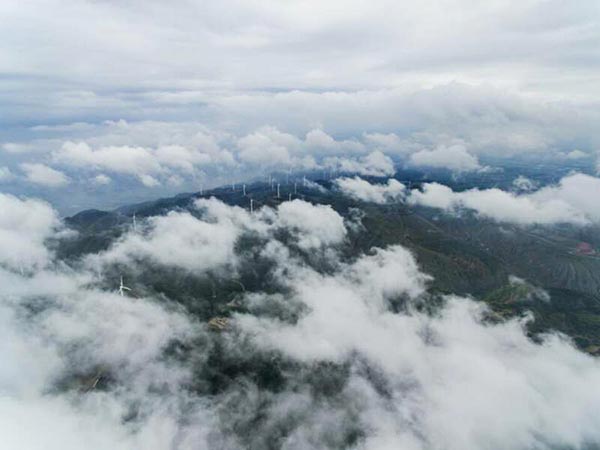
[238,243,600,450]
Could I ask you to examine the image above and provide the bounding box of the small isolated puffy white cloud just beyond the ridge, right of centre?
[409,144,482,172]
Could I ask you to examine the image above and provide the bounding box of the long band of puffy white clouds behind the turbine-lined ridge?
[41,125,393,192]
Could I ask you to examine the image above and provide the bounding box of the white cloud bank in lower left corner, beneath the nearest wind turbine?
[0,270,211,450]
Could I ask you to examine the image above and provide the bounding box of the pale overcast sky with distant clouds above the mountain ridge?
[0,0,600,212]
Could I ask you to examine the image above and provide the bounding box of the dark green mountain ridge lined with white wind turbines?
[57,180,600,353]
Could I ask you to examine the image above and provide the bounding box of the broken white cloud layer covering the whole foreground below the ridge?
[0,193,600,449]
